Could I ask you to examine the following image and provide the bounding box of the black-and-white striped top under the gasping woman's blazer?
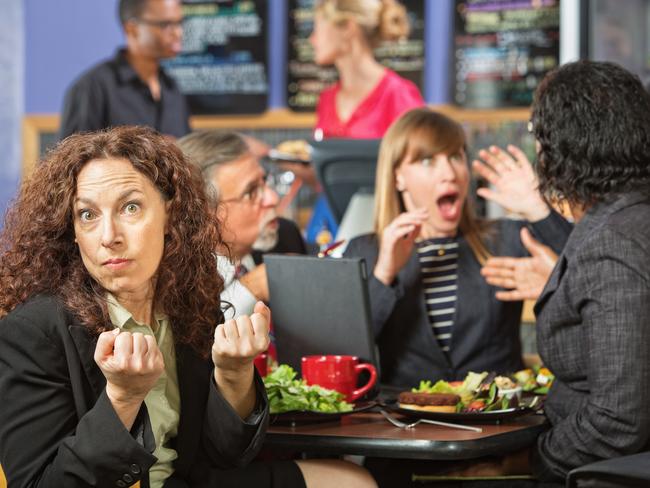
[417,237,458,353]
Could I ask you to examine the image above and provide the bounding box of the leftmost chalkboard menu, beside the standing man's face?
[164,0,268,114]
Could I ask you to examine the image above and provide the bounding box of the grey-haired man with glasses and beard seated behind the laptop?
[178,130,306,318]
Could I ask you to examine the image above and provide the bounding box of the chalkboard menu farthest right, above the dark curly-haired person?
[453,0,560,108]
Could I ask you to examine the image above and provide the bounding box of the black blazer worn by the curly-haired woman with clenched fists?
[0,296,268,488]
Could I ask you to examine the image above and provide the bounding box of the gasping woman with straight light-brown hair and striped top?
[345,108,571,388]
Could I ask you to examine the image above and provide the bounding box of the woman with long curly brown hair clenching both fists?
[0,127,368,488]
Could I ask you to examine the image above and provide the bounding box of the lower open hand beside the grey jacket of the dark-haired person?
[481,228,557,301]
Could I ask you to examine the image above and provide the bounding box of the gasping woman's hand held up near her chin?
[373,209,429,286]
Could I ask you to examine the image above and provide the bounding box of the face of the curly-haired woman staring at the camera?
[73,159,167,300]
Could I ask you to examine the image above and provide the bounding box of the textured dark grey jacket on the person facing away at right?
[533,194,650,480]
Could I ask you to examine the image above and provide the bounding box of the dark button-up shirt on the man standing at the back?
[59,49,190,139]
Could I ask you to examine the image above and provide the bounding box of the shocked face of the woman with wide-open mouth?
[395,149,469,237]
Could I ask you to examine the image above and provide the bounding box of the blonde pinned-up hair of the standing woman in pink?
[316,0,411,46]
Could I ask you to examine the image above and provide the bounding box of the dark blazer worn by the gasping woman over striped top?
[345,213,571,388]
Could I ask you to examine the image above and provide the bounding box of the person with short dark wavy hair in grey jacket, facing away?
[520,61,650,480]
